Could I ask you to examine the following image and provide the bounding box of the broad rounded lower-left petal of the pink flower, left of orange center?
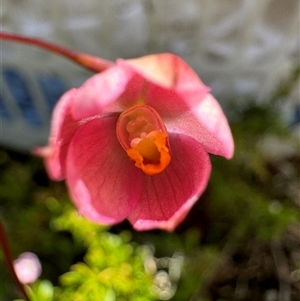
[66,117,142,224]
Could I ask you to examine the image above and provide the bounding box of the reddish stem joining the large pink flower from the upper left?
[0,31,113,72]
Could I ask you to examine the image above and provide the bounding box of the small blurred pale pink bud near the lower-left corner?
[13,252,42,284]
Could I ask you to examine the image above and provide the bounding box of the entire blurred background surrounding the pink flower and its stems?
[0,0,300,301]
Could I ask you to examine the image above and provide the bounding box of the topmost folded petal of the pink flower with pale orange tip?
[116,53,210,118]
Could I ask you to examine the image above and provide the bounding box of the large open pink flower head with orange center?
[38,54,234,231]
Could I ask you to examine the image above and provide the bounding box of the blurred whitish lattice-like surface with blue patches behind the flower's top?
[0,0,299,150]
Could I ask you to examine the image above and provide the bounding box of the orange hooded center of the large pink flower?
[116,105,171,175]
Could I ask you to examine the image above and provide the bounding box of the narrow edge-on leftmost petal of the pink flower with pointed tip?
[34,89,80,181]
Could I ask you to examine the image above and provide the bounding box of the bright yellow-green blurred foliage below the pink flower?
[53,209,155,301]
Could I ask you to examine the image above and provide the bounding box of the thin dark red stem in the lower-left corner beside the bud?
[0,220,30,301]
